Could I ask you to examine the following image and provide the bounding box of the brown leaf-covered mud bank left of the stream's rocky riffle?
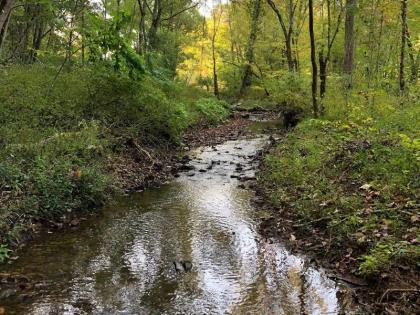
[108,112,270,192]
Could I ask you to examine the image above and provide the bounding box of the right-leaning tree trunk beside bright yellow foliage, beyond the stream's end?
[240,0,261,95]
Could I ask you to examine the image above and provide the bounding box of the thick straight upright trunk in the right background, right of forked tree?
[343,0,357,82]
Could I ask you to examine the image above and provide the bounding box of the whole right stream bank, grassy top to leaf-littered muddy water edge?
[257,120,420,314]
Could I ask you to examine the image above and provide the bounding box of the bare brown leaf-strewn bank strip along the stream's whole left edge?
[0,112,260,261]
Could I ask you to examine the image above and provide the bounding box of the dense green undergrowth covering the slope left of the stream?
[0,65,229,254]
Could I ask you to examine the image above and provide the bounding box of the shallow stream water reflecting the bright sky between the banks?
[0,126,356,315]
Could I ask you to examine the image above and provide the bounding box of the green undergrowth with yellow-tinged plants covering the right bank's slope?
[259,85,420,277]
